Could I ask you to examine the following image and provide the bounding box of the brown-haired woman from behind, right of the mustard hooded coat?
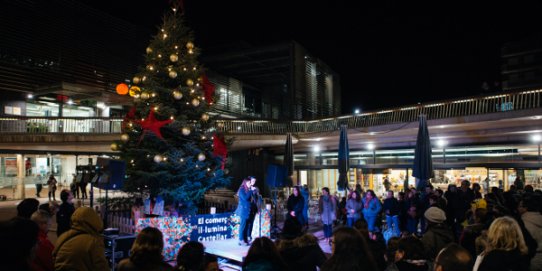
[118,227,172,271]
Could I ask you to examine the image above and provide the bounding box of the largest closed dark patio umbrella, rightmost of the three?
[412,115,434,191]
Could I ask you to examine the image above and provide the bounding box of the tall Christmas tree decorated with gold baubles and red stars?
[111,5,233,216]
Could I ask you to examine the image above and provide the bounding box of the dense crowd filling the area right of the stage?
[312,180,542,271]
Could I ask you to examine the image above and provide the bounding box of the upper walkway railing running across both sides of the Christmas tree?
[0,89,542,134]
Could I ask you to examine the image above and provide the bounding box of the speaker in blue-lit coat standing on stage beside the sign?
[235,178,253,246]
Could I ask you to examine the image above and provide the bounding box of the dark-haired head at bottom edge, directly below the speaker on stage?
[242,237,288,271]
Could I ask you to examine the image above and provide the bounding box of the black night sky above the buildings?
[80,0,542,113]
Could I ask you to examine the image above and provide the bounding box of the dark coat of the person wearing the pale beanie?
[422,224,454,260]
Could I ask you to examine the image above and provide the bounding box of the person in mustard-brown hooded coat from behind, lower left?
[53,207,110,271]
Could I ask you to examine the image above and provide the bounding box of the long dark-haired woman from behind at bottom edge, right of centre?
[321,227,378,271]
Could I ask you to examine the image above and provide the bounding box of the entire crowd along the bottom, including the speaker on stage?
[0,177,542,271]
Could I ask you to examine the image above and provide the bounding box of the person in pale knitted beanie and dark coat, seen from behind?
[422,207,454,261]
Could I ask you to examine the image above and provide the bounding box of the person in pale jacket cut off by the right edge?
[518,197,542,271]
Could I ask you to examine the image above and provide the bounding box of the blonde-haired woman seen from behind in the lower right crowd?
[472,216,529,271]
